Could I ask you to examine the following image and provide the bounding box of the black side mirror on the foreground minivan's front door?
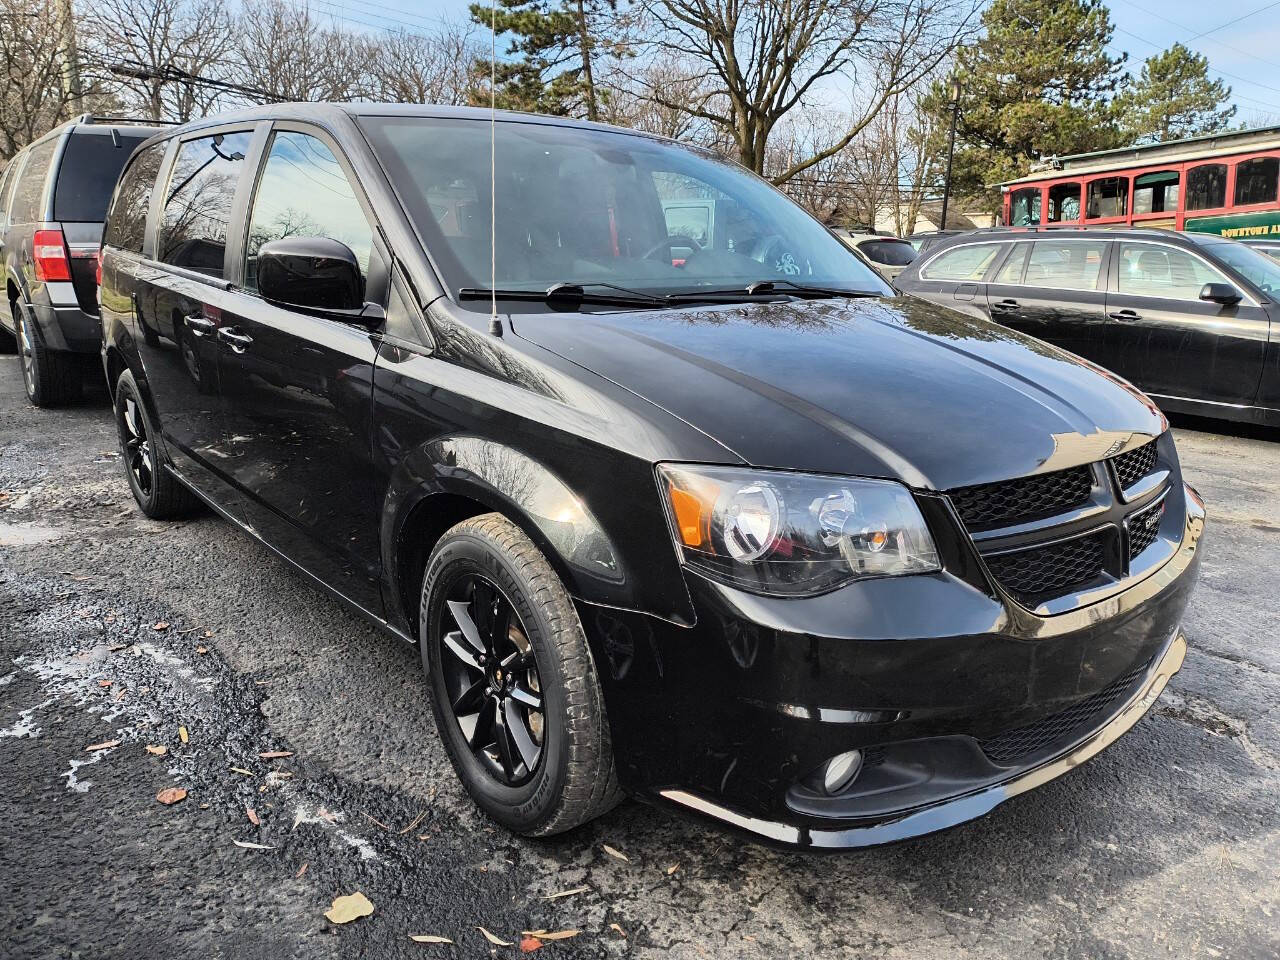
[255,237,365,319]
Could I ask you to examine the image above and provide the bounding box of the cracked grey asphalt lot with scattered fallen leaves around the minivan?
[0,357,1280,960]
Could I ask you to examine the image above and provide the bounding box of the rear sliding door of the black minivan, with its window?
[133,131,252,506]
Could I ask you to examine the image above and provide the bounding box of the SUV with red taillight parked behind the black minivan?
[0,114,167,407]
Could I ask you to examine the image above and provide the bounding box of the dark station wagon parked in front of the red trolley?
[897,228,1280,425]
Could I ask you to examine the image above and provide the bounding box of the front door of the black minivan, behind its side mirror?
[207,129,381,613]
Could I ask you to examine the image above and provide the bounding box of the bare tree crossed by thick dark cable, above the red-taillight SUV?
[81,0,236,123]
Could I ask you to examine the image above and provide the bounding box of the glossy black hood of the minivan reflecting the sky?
[512,298,1165,489]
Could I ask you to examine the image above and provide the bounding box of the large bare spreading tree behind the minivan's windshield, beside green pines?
[641,0,978,183]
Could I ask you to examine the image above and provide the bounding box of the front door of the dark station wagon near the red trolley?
[1107,241,1268,404]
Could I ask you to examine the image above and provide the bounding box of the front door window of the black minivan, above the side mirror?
[244,132,374,291]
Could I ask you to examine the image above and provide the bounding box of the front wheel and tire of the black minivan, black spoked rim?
[419,513,622,837]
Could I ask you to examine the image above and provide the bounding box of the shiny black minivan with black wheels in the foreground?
[101,104,1204,847]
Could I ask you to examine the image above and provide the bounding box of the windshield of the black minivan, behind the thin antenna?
[361,116,892,308]
